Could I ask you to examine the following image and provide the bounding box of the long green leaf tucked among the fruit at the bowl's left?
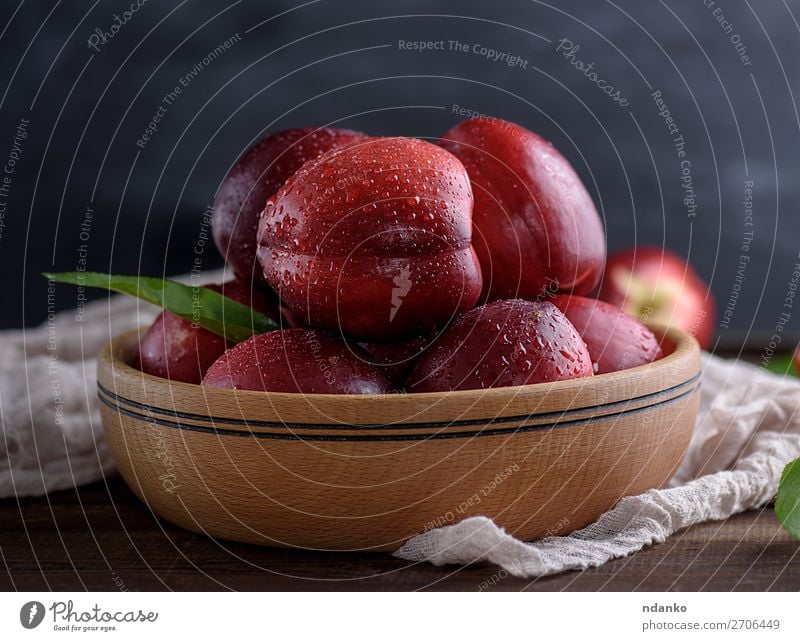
[42,272,278,343]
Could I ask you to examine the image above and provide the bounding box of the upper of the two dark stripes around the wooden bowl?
[97,373,700,431]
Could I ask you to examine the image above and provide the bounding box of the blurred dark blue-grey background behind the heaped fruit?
[0,0,800,338]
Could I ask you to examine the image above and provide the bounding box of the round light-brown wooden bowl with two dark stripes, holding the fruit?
[98,330,700,550]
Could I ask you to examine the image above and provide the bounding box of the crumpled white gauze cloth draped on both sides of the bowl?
[0,288,800,577]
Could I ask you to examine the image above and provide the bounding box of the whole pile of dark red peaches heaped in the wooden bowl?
[139,118,662,394]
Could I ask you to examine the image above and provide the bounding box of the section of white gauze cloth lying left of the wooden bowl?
[0,270,226,498]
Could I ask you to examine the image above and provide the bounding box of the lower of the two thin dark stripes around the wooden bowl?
[97,383,700,441]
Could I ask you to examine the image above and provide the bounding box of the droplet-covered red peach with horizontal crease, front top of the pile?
[258,138,481,342]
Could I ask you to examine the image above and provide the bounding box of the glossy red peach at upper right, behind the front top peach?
[439,118,605,301]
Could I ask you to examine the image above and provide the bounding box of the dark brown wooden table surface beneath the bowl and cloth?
[0,478,800,591]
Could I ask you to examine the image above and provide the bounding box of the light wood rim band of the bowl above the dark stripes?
[98,326,699,432]
